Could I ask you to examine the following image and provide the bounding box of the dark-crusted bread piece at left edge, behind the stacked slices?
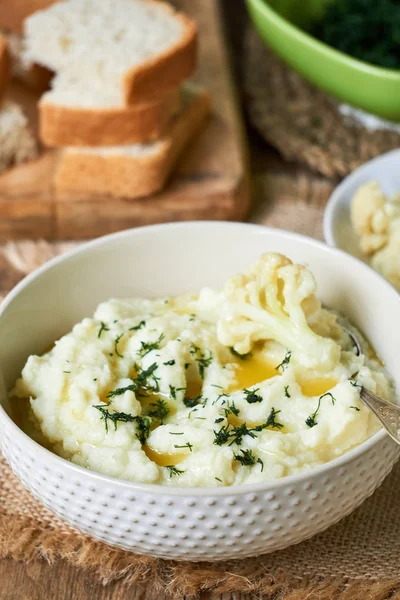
[0,30,54,93]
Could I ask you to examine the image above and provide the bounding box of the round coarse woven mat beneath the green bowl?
[242,26,400,177]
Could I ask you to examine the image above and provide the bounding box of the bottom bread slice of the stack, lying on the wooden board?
[55,90,210,198]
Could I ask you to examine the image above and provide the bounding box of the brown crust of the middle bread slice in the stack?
[39,89,180,147]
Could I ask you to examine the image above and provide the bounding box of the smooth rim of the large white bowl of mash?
[0,221,400,497]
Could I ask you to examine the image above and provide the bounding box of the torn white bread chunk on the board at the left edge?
[0,100,38,173]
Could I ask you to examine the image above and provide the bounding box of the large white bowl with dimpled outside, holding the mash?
[0,222,400,561]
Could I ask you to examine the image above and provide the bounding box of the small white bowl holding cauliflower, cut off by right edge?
[323,150,400,261]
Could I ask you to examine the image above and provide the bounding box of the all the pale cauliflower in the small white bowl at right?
[351,181,400,291]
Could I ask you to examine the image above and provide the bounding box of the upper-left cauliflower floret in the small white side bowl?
[351,181,389,254]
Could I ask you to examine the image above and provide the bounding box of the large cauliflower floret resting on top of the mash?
[217,252,340,371]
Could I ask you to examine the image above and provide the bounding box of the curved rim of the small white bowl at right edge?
[322,148,400,250]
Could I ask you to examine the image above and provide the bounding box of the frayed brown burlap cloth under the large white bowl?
[0,242,400,600]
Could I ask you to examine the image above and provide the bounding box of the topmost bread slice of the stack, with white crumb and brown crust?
[25,0,197,105]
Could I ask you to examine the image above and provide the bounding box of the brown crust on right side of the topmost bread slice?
[123,8,197,104]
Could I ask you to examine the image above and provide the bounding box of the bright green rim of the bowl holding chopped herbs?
[246,0,400,82]
